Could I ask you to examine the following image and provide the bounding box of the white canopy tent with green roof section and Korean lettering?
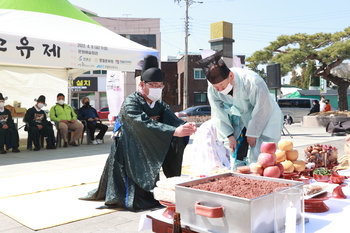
[0,0,158,108]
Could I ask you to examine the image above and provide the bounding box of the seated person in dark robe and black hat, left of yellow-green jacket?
[23,95,56,151]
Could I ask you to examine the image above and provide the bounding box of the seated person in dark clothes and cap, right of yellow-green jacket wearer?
[78,96,108,145]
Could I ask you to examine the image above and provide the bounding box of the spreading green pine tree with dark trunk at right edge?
[246,27,350,111]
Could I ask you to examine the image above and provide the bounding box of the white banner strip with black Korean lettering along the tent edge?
[0,32,152,71]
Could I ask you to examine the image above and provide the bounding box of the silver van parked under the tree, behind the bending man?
[277,98,317,123]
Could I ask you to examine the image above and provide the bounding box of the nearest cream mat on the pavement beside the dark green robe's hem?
[0,182,118,230]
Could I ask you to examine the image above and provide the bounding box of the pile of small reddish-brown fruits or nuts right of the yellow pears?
[304,144,338,167]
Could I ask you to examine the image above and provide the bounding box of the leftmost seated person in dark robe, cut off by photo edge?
[0,93,20,154]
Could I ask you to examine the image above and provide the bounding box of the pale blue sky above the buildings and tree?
[68,0,350,60]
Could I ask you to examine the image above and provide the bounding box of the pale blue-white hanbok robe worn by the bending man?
[208,68,283,162]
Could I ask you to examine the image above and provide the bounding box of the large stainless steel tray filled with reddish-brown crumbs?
[175,173,303,233]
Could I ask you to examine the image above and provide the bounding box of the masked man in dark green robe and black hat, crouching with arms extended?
[80,56,196,210]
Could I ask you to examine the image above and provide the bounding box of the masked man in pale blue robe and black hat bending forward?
[198,51,283,163]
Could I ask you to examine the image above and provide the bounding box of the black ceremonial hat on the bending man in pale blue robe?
[197,50,231,84]
